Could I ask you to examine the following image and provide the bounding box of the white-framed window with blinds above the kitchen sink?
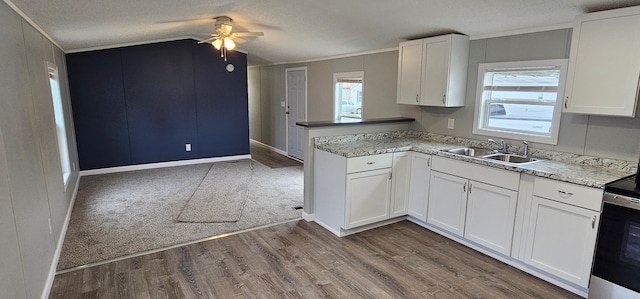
[473,59,567,144]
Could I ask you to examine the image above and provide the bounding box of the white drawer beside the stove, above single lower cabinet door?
[533,177,603,211]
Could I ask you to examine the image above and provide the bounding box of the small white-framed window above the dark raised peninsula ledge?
[333,72,364,120]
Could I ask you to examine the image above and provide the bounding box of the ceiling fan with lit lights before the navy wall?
[197,16,264,61]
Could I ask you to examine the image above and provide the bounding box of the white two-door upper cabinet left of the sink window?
[397,34,469,107]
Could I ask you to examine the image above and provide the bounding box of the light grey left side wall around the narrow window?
[0,2,78,298]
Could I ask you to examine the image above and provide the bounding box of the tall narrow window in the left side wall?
[47,62,71,186]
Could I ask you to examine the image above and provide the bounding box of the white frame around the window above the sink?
[473,59,567,145]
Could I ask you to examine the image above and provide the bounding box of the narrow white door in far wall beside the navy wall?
[285,68,307,160]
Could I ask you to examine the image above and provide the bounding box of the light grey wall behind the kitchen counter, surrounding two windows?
[249,29,640,161]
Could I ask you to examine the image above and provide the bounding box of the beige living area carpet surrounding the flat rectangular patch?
[57,160,304,270]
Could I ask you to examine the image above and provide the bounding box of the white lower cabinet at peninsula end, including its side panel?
[314,149,411,236]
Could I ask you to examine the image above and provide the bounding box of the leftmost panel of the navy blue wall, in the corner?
[67,50,131,169]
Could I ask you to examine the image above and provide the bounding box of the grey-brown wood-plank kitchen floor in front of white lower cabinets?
[50,220,579,298]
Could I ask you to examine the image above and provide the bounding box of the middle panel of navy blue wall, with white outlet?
[121,41,197,164]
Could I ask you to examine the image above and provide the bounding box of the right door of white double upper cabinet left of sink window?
[420,39,450,106]
